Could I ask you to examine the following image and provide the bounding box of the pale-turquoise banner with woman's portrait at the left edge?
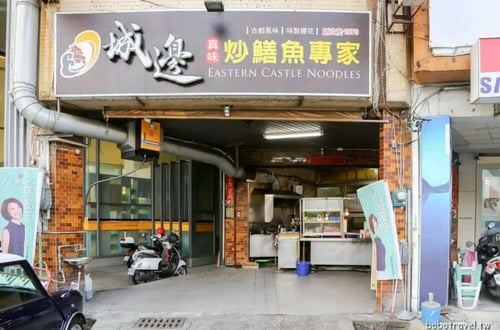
[0,167,43,265]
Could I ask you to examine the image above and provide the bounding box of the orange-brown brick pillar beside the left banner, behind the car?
[36,142,84,290]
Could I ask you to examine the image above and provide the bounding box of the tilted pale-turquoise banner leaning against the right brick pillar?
[357,180,402,280]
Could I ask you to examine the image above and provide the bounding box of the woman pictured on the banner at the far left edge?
[0,198,25,257]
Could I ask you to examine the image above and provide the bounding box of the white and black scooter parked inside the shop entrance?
[128,232,187,284]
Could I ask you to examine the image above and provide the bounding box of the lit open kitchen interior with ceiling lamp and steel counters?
[160,117,380,278]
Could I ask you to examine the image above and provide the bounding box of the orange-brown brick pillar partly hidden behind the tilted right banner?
[376,112,413,313]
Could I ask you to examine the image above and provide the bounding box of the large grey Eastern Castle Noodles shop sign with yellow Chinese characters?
[55,11,371,98]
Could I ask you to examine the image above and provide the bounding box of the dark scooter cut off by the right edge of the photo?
[466,222,500,301]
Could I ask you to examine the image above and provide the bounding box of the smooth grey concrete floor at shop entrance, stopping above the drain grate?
[86,259,376,314]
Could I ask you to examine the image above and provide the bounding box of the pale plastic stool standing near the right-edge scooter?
[453,263,482,309]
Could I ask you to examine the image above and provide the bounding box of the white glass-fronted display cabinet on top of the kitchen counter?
[300,197,345,237]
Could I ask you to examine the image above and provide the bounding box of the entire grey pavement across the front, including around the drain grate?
[84,258,500,330]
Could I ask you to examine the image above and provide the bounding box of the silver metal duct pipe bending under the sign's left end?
[10,0,244,177]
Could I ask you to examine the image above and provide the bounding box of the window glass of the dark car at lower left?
[0,265,43,310]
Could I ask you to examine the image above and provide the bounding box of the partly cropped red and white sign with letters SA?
[470,38,500,103]
